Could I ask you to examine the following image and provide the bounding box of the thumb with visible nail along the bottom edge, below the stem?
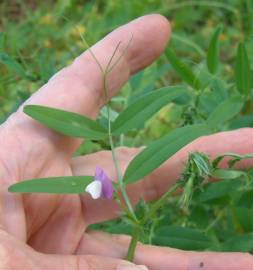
[43,254,148,270]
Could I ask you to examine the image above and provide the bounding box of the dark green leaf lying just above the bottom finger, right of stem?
[153,226,213,250]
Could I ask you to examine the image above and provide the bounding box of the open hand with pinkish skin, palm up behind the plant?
[0,15,253,270]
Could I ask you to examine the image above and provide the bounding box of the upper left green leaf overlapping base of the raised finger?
[24,105,107,139]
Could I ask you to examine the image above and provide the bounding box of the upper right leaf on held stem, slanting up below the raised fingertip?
[112,86,186,135]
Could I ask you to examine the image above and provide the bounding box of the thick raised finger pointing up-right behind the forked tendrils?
[8,15,170,156]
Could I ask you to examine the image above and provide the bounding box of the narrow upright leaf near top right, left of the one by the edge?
[207,27,222,74]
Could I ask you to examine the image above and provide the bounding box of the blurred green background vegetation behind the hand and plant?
[0,0,253,251]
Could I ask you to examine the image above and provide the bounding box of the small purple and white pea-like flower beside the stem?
[85,167,114,199]
